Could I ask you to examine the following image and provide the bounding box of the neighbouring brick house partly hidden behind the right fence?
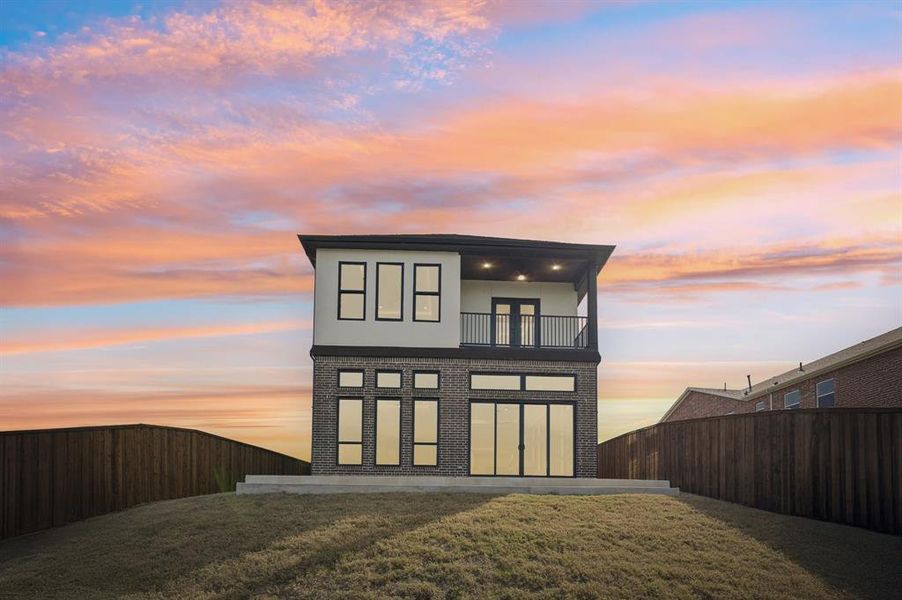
[661,327,902,422]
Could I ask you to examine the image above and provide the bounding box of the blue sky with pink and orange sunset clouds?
[0,0,902,458]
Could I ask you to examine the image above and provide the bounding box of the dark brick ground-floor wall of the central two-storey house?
[311,355,598,477]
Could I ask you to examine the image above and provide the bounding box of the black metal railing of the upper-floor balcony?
[460,312,589,350]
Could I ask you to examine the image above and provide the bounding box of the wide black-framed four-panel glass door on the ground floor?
[470,402,574,477]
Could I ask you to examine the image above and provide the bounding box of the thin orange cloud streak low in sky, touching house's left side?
[0,321,310,355]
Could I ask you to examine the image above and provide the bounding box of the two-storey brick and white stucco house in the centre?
[298,235,614,477]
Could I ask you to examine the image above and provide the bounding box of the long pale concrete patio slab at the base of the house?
[237,475,679,496]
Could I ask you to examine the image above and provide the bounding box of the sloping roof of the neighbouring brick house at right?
[661,327,902,421]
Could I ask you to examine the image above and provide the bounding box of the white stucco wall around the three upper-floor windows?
[313,249,460,348]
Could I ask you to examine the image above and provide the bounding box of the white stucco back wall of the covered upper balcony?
[460,279,577,317]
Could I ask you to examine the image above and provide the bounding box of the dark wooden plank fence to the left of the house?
[0,425,310,539]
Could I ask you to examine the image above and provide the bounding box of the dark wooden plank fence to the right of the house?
[598,408,902,534]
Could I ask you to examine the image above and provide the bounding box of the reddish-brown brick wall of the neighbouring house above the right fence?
[666,347,902,421]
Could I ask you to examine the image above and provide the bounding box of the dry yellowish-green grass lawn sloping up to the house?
[0,494,902,599]
